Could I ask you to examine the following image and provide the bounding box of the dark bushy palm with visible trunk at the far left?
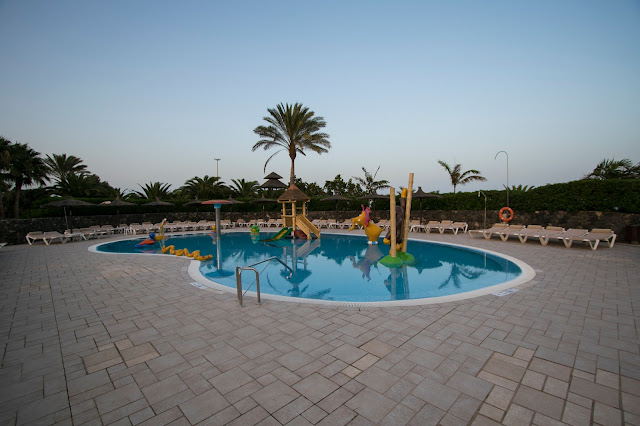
[6,143,49,218]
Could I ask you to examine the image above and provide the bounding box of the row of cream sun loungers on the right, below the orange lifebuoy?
[469,223,616,250]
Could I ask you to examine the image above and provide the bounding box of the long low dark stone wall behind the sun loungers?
[0,208,640,244]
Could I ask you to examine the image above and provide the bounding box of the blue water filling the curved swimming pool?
[96,232,522,302]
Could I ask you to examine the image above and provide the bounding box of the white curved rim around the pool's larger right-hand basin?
[188,232,536,308]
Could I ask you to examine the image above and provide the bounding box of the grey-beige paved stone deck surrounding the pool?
[0,230,640,426]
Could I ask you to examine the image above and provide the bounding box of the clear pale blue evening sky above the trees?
[0,0,640,192]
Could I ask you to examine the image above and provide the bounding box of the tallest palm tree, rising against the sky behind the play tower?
[252,103,331,185]
